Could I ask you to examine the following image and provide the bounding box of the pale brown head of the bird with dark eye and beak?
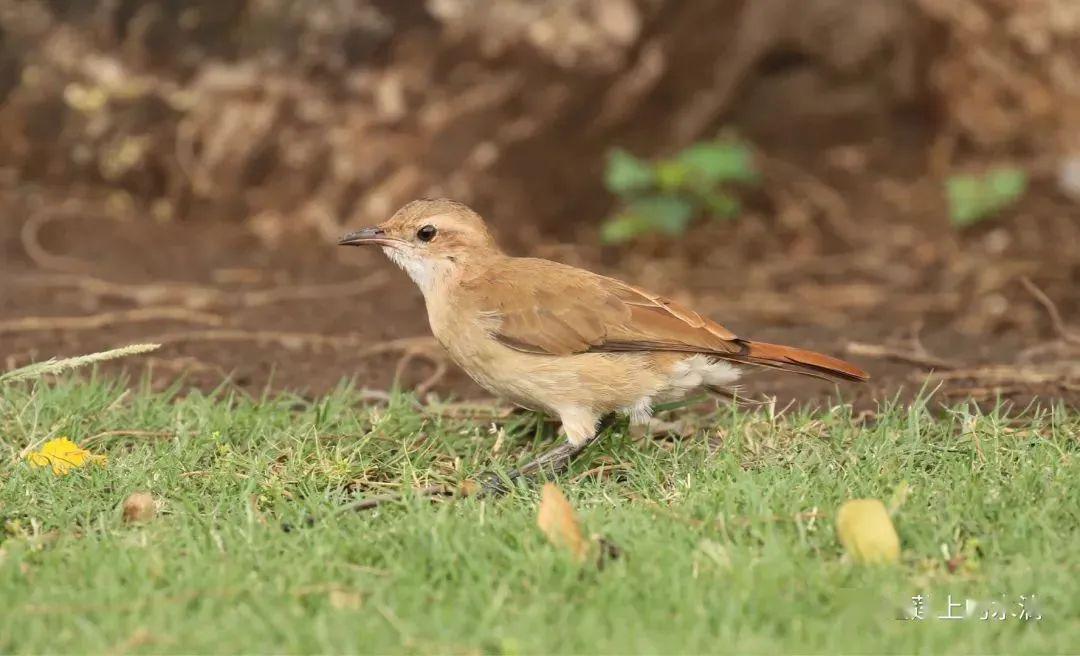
[338,199,500,293]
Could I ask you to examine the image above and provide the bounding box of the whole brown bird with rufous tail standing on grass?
[338,199,869,484]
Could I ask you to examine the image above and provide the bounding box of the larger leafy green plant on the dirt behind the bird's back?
[602,139,758,243]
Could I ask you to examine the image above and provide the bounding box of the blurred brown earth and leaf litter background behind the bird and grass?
[0,0,1080,402]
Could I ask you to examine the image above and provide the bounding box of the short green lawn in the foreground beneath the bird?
[0,379,1080,653]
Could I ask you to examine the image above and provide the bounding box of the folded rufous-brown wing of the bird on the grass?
[470,259,745,356]
